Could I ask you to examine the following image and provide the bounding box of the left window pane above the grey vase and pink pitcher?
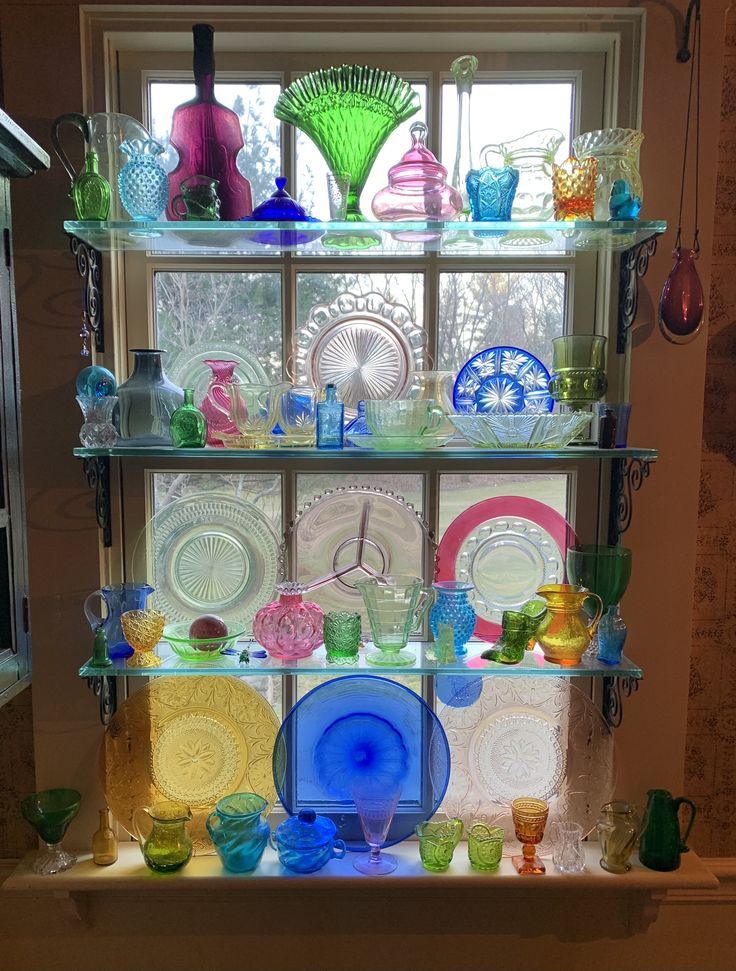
[154,272,283,394]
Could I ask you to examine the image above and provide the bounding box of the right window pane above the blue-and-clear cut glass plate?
[437,273,565,382]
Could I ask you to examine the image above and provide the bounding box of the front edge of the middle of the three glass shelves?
[74,444,659,466]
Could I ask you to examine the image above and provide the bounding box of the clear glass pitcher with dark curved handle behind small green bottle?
[51,111,151,219]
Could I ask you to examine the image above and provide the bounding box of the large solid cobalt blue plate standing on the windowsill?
[273,675,450,850]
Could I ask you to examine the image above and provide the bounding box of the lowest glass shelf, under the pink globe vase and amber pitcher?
[79,641,642,678]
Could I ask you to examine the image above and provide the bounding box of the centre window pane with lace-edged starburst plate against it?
[293,273,426,409]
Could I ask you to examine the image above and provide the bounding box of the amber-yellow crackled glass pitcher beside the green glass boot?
[537,583,603,667]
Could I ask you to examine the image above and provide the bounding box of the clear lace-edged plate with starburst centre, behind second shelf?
[295,293,427,410]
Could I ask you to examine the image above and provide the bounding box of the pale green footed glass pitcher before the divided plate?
[355,574,431,665]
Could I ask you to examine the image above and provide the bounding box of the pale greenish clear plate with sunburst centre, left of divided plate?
[147,493,279,627]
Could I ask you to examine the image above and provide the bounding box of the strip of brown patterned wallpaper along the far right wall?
[685,6,736,856]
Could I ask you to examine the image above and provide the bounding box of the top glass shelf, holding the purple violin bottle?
[64,220,667,254]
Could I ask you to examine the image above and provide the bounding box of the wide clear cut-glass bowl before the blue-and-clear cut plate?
[450,411,591,448]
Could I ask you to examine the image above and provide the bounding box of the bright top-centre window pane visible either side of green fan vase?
[296,84,432,219]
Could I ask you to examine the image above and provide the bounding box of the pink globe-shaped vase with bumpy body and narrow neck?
[253,582,325,661]
